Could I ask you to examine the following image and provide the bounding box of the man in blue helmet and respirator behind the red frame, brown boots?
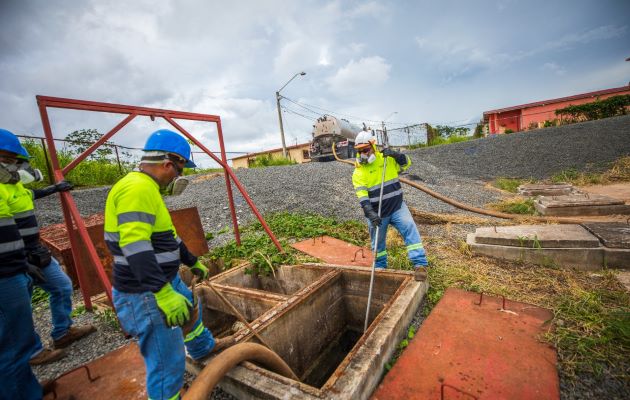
[0,130,96,372]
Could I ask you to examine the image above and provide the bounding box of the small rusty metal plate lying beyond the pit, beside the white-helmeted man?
[291,236,372,267]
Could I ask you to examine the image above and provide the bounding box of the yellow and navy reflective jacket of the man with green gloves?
[105,172,197,293]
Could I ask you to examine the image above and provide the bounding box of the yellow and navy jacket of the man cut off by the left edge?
[0,184,26,278]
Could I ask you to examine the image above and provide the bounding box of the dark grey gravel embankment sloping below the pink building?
[411,115,630,179]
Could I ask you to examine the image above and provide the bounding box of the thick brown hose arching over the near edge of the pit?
[183,343,299,400]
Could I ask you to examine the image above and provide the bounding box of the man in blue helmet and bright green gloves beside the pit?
[105,129,233,399]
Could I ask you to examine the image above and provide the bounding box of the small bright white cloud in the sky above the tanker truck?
[327,56,391,96]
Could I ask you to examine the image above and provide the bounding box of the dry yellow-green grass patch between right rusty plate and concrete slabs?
[423,231,630,377]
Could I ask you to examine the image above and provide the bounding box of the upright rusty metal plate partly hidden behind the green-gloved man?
[40,207,209,296]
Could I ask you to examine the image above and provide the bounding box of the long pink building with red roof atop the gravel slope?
[483,85,630,133]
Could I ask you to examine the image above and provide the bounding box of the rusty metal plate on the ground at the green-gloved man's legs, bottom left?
[44,343,147,400]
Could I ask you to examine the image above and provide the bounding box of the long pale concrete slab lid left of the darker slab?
[475,224,600,248]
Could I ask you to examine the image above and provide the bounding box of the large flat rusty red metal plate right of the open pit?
[372,288,560,400]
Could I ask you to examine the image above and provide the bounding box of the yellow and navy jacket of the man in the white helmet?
[352,150,411,217]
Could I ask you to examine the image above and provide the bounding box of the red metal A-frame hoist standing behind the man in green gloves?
[36,96,283,309]
